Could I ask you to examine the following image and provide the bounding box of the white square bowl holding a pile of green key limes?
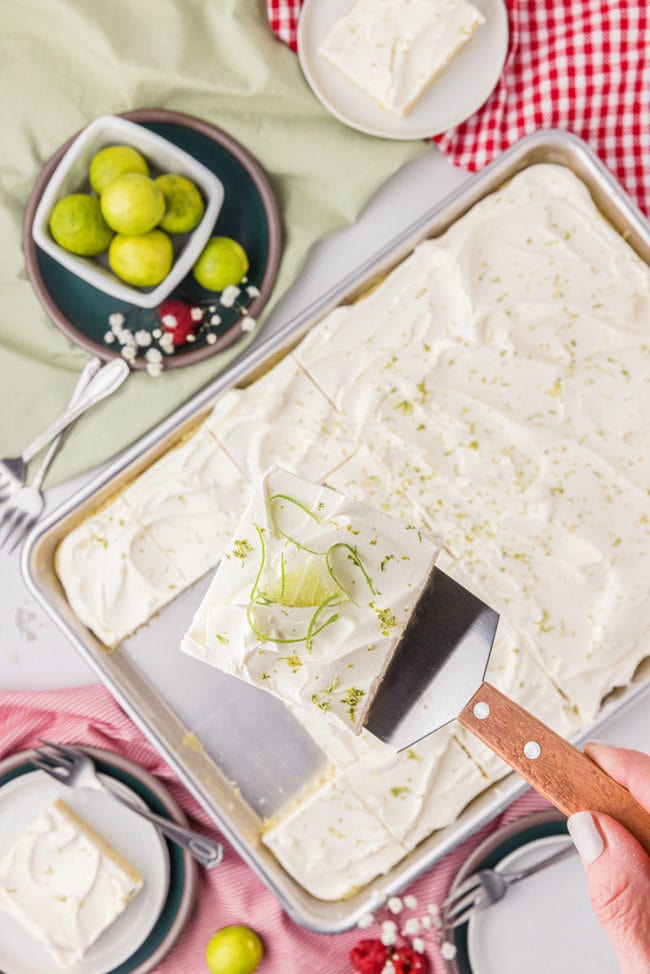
[32,115,224,308]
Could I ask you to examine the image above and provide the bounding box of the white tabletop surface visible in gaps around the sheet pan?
[0,147,650,750]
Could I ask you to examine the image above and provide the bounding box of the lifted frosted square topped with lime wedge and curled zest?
[182,468,438,729]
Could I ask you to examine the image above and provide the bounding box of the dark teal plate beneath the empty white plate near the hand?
[446,811,568,974]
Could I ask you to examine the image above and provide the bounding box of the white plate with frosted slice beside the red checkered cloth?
[298,0,508,139]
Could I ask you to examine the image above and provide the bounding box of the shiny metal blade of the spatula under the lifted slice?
[365,567,499,751]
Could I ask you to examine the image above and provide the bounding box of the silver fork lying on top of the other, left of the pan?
[0,358,130,510]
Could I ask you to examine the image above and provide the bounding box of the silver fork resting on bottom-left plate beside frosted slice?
[29,741,223,869]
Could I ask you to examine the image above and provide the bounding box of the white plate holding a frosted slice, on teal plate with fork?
[0,771,169,974]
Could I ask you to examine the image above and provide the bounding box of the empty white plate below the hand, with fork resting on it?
[467,835,619,974]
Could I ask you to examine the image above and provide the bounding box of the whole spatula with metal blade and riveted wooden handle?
[365,568,650,852]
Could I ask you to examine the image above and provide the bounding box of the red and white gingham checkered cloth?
[268,0,650,214]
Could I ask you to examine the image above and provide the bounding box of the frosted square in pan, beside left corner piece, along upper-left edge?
[120,429,251,585]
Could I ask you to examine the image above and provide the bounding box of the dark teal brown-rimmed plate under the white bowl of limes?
[23,108,281,368]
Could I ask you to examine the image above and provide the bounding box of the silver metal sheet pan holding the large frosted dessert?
[22,131,650,933]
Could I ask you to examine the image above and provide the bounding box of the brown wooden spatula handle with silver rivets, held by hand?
[459,683,650,853]
